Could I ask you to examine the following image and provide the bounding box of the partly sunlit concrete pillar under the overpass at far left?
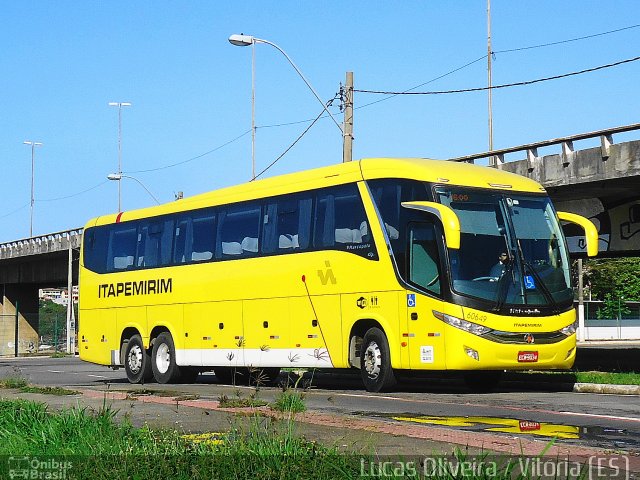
[0,284,39,356]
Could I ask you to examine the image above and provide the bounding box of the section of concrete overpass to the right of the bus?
[452,124,640,257]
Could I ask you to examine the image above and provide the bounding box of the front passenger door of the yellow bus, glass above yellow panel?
[402,221,445,370]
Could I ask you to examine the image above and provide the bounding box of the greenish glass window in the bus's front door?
[408,223,440,295]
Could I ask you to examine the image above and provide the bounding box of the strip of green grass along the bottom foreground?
[0,400,586,480]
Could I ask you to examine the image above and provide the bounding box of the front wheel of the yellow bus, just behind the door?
[360,327,396,392]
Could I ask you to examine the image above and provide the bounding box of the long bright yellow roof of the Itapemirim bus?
[87,158,545,227]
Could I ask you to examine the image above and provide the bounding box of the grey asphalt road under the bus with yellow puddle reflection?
[0,357,640,454]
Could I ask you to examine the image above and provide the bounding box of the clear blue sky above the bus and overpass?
[0,0,640,242]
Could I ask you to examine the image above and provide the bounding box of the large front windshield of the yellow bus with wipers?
[436,187,573,310]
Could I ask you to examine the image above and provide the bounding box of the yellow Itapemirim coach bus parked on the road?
[79,159,597,392]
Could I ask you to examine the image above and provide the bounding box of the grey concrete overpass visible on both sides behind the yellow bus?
[0,124,640,356]
